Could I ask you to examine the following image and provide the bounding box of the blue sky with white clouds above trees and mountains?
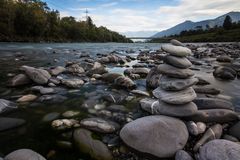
[43,0,240,36]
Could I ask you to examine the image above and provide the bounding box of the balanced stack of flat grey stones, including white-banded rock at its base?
[140,41,198,117]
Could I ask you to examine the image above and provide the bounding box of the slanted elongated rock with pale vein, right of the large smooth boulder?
[193,124,223,152]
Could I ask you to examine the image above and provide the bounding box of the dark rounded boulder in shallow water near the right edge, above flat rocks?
[213,67,237,80]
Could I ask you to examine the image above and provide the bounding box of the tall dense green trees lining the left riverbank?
[0,0,131,42]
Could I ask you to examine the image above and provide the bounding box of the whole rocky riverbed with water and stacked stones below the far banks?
[0,40,240,160]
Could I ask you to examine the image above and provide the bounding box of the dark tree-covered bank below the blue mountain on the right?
[150,16,240,43]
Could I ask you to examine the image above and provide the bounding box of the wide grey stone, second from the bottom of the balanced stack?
[153,87,197,104]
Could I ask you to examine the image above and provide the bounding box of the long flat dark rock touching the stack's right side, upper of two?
[194,98,234,110]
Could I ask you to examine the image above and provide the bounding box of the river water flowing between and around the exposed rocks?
[0,43,240,160]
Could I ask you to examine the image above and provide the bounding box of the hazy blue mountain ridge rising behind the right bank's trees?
[152,12,240,38]
